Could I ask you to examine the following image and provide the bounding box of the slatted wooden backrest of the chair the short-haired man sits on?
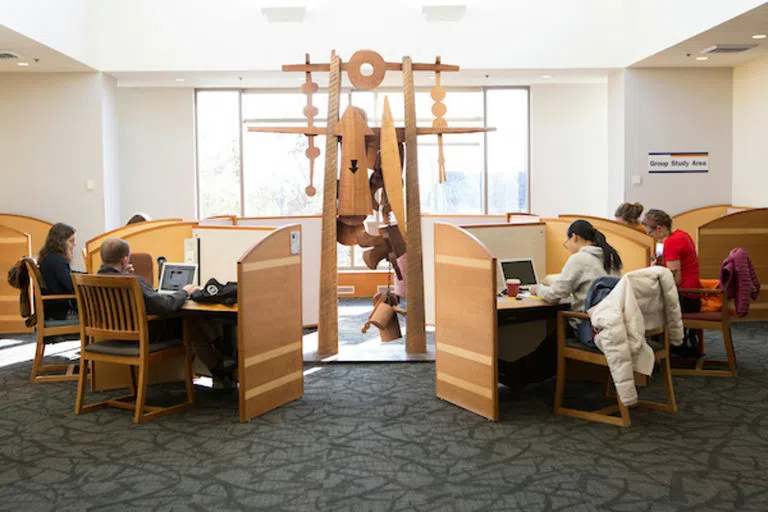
[72,274,149,355]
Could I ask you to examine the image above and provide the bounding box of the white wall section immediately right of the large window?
[531,84,613,217]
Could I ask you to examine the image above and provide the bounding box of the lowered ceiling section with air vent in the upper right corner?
[632,4,768,68]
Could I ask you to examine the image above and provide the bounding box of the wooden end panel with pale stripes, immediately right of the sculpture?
[434,223,499,421]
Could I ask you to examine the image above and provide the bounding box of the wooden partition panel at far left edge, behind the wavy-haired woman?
[0,225,32,333]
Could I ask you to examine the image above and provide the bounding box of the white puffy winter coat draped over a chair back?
[589,266,683,405]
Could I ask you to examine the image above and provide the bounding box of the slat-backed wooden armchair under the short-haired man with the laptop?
[74,275,194,423]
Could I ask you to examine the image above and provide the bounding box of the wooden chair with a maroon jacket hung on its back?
[672,288,738,377]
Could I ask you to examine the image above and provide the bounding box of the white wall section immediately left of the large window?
[117,88,197,222]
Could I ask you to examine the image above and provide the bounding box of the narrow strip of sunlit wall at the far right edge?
[732,57,768,207]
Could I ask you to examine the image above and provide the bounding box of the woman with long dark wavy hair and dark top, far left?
[38,223,77,320]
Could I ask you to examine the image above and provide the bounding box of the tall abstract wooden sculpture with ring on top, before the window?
[248,50,492,354]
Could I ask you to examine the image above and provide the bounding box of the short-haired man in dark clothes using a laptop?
[98,238,236,388]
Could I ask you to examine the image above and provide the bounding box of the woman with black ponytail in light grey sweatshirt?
[531,219,622,327]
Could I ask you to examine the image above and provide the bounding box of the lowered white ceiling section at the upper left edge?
[0,25,93,73]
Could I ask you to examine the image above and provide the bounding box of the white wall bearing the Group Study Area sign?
[625,68,733,214]
